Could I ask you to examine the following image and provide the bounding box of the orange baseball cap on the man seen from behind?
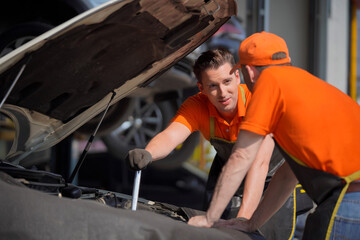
[231,31,291,73]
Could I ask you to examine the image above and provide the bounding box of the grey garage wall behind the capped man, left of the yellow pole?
[237,0,350,93]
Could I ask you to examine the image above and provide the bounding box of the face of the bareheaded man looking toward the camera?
[198,63,240,117]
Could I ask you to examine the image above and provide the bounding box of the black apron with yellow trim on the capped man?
[276,143,360,240]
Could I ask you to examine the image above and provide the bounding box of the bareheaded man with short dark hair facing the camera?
[127,49,274,218]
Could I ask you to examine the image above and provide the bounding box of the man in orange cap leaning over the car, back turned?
[189,32,360,240]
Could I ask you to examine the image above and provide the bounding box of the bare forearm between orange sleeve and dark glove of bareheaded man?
[145,122,191,160]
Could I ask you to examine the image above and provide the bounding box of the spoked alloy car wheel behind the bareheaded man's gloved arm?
[103,98,199,170]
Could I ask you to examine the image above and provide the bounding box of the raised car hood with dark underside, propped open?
[0,0,236,163]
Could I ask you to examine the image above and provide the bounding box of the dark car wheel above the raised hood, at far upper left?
[0,22,54,57]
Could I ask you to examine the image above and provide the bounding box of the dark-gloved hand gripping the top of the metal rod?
[125,148,152,171]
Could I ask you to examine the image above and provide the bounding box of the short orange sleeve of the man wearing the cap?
[240,69,285,135]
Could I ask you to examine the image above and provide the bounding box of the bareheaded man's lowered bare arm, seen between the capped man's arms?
[237,135,275,219]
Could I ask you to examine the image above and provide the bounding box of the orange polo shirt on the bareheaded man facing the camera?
[171,84,251,141]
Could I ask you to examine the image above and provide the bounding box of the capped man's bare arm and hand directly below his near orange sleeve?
[189,130,264,227]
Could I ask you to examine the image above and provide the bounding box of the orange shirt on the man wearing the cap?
[240,66,360,177]
